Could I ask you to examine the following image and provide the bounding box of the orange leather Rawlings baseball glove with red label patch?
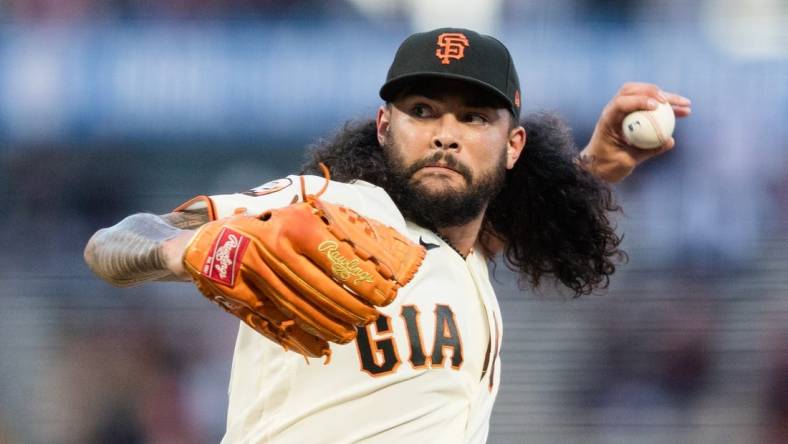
[183,167,425,362]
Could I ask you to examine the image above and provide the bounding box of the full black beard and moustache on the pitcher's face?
[383,144,506,230]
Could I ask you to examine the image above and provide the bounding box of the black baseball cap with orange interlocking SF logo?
[380,28,521,118]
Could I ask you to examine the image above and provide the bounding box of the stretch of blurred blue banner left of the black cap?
[0,25,398,141]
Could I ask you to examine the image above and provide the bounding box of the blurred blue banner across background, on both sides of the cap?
[0,23,788,143]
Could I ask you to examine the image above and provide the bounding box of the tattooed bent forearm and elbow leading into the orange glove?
[84,213,192,286]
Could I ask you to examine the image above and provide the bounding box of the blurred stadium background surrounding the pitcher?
[0,0,788,444]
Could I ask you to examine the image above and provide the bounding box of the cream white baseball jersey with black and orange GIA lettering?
[179,176,502,444]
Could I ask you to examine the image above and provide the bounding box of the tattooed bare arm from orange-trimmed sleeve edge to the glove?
[84,210,209,287]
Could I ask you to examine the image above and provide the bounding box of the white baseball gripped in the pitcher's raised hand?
[621,103,676,150]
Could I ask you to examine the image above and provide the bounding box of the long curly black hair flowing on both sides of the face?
[302,112,626,296]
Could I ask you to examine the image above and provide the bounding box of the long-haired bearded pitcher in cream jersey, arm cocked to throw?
[85,28,690,443]
